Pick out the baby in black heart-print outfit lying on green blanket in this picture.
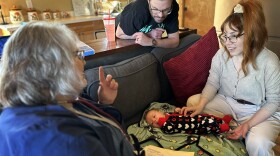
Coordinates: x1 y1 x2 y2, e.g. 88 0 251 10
144 108 232 134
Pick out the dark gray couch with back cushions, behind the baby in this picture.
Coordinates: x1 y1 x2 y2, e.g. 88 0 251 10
85 34 201 126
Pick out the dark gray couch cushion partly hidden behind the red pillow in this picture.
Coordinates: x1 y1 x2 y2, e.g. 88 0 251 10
151 34 201 104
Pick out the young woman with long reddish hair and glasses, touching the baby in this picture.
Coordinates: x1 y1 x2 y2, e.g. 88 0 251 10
183 0 280 156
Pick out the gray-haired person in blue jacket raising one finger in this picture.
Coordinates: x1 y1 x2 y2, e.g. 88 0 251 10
0 22 133 156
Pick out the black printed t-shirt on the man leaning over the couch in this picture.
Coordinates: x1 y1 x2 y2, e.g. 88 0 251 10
120 0 179 36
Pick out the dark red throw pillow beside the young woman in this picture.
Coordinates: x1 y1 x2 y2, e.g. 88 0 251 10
163 27 219 106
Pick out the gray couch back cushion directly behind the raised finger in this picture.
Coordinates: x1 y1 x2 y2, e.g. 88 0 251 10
85 53 160 125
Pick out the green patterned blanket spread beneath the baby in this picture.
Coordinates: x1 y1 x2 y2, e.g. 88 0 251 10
128 102 248 156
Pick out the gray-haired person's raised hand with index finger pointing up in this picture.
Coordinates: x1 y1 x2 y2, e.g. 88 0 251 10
97 67 119 104
